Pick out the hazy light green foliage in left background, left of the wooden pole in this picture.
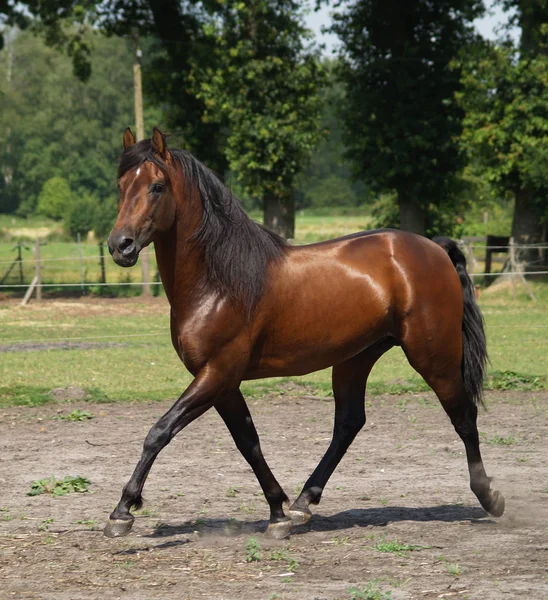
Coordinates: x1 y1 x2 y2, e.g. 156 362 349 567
0 32 139 218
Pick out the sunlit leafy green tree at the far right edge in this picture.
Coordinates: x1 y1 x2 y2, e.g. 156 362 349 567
457 0 548 253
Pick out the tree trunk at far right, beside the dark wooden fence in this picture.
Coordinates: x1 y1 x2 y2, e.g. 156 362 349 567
512 189 543 263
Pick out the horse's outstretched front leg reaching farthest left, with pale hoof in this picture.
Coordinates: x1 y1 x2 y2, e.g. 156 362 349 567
104 368 226 537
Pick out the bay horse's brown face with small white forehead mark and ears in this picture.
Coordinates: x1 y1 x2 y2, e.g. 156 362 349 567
108 128 175 267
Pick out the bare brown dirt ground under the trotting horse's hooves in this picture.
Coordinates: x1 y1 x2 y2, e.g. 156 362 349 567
0 392 548 600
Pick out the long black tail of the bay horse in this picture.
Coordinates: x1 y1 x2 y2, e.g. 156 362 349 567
432 237 487 404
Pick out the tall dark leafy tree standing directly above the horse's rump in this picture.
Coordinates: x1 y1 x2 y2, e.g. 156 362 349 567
333 0 483 234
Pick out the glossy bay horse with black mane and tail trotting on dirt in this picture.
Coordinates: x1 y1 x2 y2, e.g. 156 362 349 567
105 129 504 537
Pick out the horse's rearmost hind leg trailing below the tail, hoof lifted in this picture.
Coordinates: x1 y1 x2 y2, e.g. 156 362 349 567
404 343 504 517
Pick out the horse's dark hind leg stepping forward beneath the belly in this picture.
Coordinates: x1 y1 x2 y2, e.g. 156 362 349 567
289 338 394 525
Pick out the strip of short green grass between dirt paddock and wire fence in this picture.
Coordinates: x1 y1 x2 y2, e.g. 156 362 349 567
0 284 548 405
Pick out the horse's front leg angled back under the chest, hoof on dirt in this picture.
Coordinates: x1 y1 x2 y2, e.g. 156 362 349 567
215 390 293 539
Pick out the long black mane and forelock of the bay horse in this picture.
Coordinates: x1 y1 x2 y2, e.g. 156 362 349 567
118 140 287 314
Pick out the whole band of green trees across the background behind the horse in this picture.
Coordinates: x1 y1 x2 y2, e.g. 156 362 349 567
0 0 548 242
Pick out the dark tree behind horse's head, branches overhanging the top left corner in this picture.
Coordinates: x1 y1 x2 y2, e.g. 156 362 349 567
0 0 227 173
